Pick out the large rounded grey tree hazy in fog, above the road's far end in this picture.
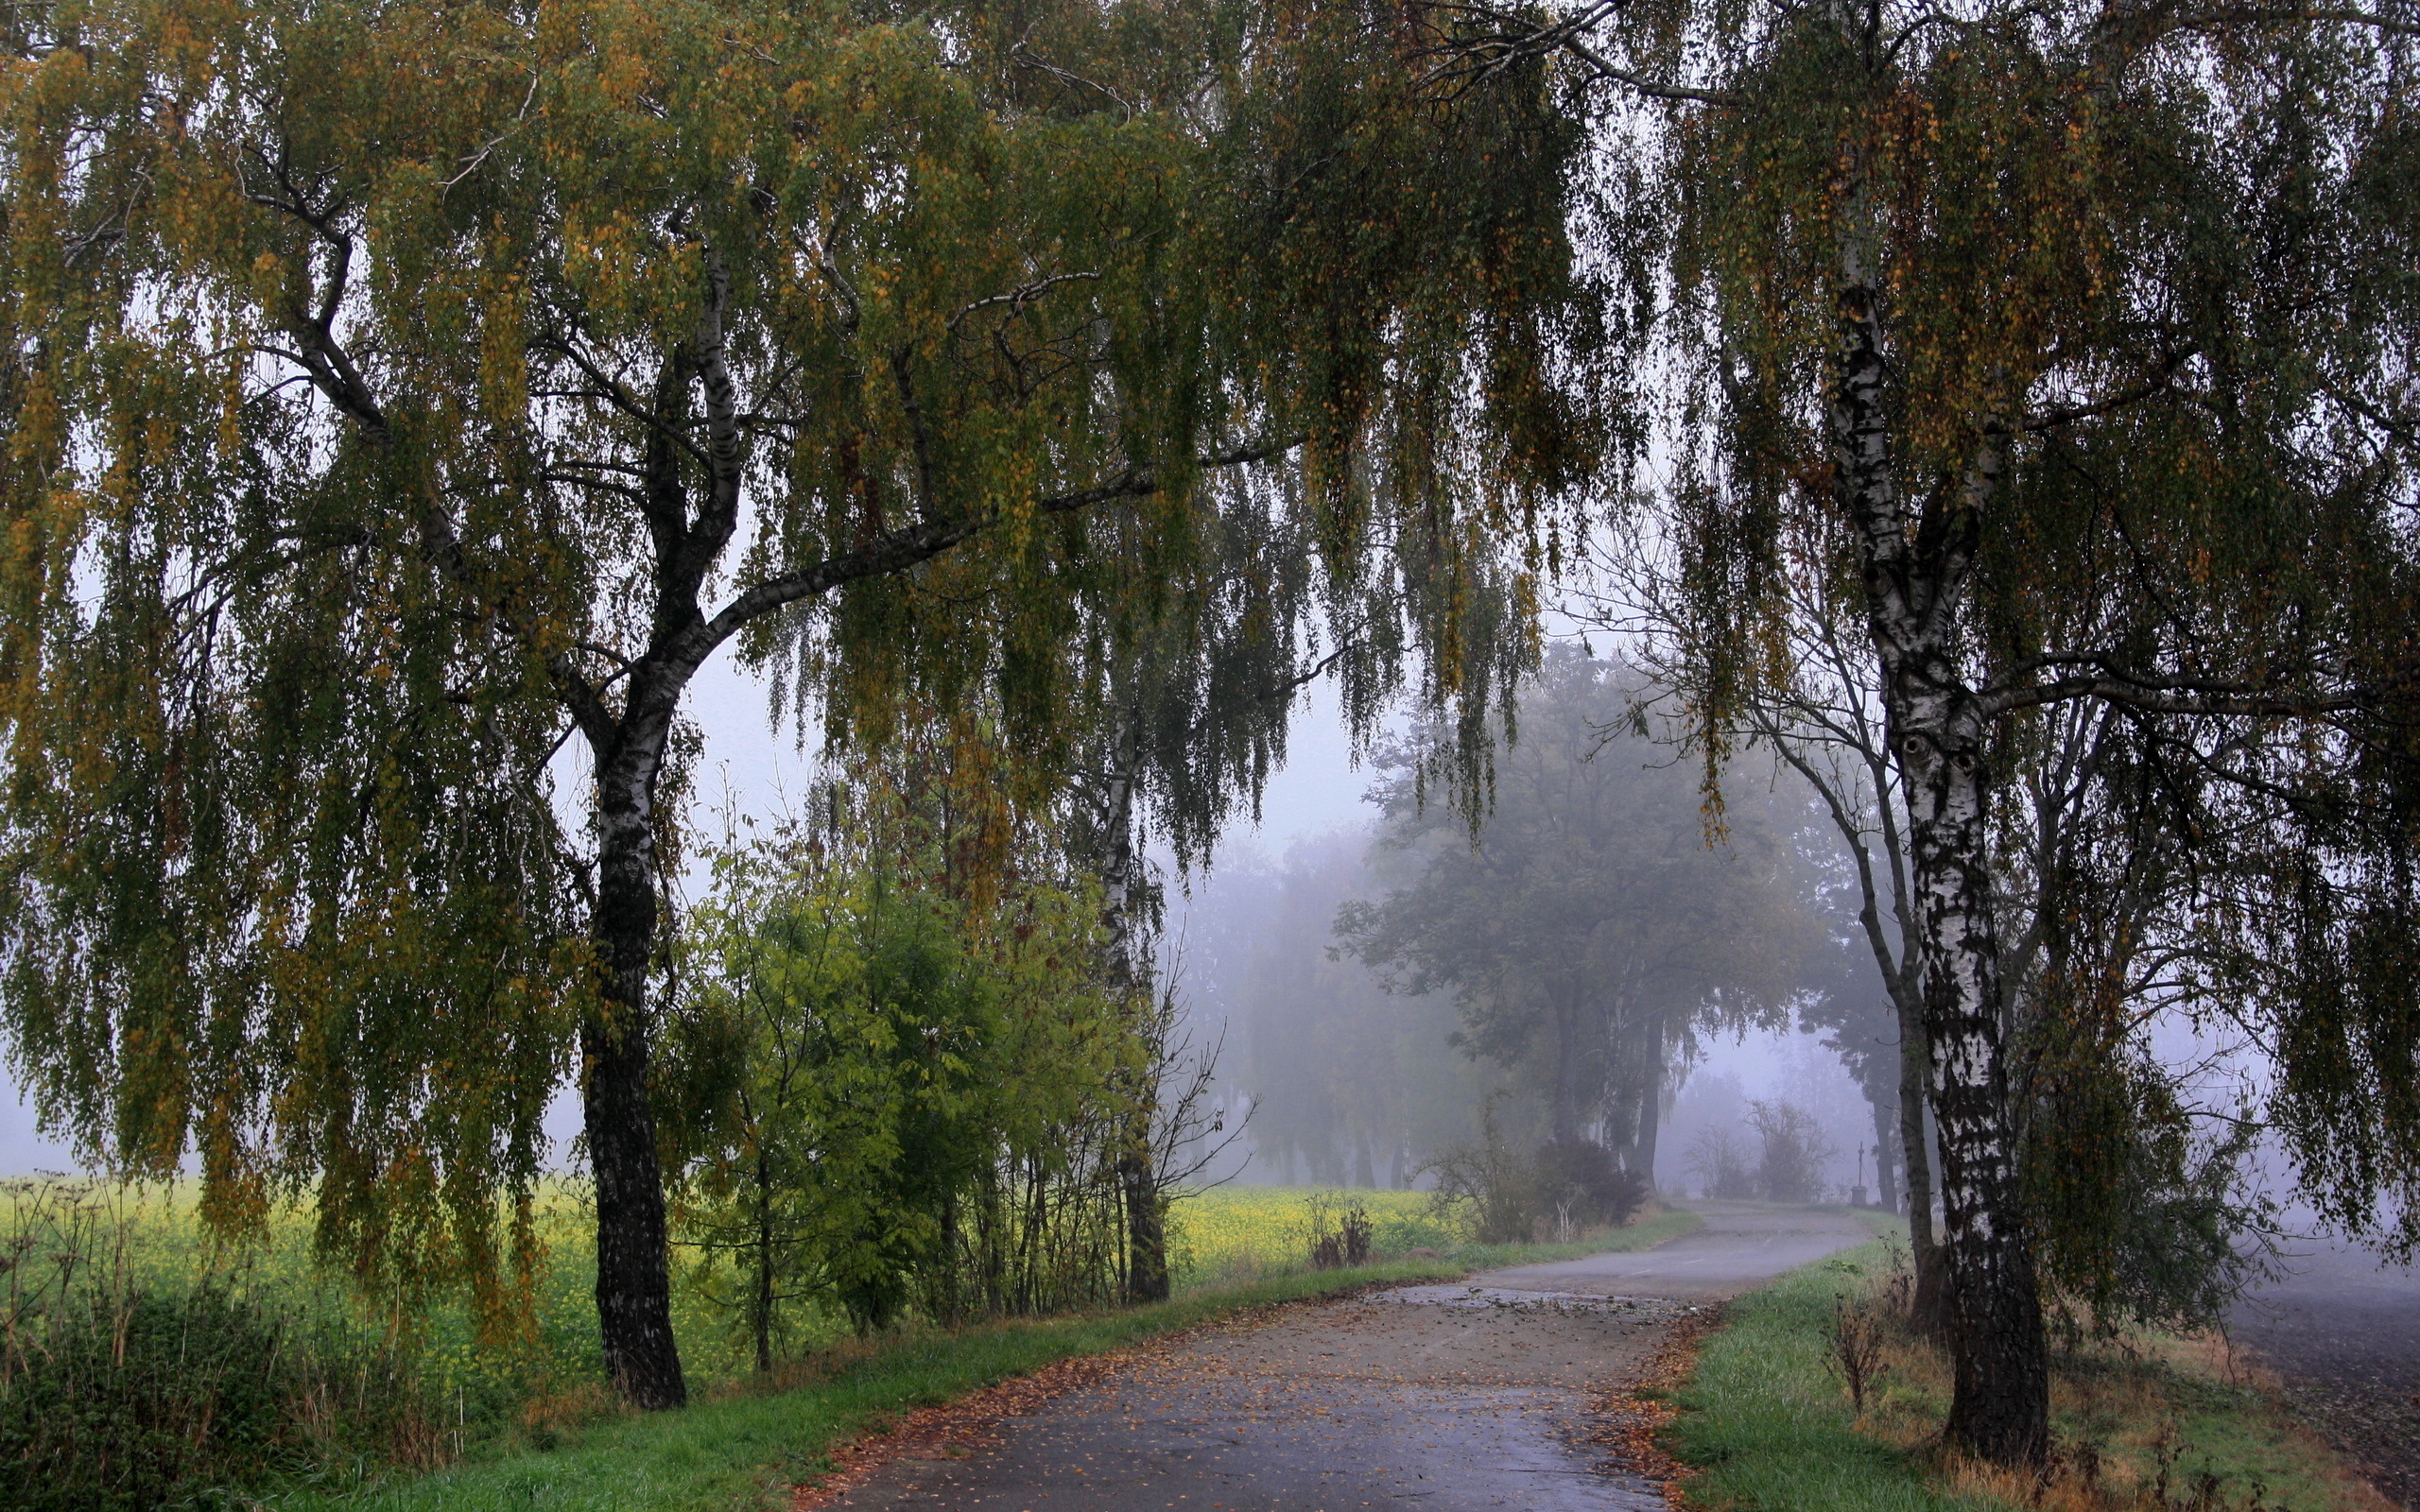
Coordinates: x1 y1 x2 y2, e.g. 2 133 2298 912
1336 648 1803 1178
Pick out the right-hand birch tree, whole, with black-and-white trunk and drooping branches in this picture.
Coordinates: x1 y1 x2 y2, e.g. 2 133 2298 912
1435 0 2420 1464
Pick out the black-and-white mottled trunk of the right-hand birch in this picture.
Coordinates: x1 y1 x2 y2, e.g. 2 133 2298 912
1829 167 2049 1466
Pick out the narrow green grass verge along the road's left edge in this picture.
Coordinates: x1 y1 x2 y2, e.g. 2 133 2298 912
256 1212 1702 1512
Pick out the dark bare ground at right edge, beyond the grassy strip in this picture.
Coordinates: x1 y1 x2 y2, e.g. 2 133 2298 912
2229 1241 2420 1512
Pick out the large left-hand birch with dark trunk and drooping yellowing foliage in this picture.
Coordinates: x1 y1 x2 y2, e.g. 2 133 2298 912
0 0 1604 1408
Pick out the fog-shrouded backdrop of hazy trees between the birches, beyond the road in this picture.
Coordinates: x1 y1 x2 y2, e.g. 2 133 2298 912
1171 648 1900 1205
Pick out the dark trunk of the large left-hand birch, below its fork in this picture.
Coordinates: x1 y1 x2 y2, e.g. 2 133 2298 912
580 747 690 1408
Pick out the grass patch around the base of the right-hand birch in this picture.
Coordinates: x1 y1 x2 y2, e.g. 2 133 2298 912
1665 1214 2386 1512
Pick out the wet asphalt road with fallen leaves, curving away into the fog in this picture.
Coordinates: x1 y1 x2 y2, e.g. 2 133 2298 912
828 1202 1871 1512
